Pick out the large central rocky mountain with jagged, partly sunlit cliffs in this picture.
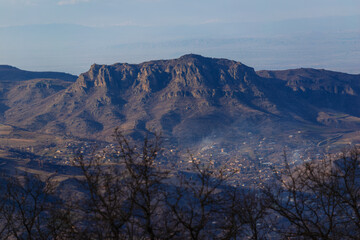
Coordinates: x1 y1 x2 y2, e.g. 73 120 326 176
60 55 277 141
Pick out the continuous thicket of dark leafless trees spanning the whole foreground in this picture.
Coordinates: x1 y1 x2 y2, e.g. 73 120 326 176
8 130 354 240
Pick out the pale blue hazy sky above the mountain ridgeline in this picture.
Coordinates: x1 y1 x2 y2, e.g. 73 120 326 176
0 0 360 74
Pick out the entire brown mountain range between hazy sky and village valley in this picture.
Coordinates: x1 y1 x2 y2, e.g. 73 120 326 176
0 54 360 151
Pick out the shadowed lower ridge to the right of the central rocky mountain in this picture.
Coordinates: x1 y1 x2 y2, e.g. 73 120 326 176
257 68 360 127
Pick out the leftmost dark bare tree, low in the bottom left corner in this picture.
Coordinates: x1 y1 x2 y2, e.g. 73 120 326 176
1 173 56 239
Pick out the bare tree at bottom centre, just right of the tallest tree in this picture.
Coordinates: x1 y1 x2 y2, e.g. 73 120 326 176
167 157 234 239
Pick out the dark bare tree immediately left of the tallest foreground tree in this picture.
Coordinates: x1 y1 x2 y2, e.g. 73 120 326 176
73 144 134 239
